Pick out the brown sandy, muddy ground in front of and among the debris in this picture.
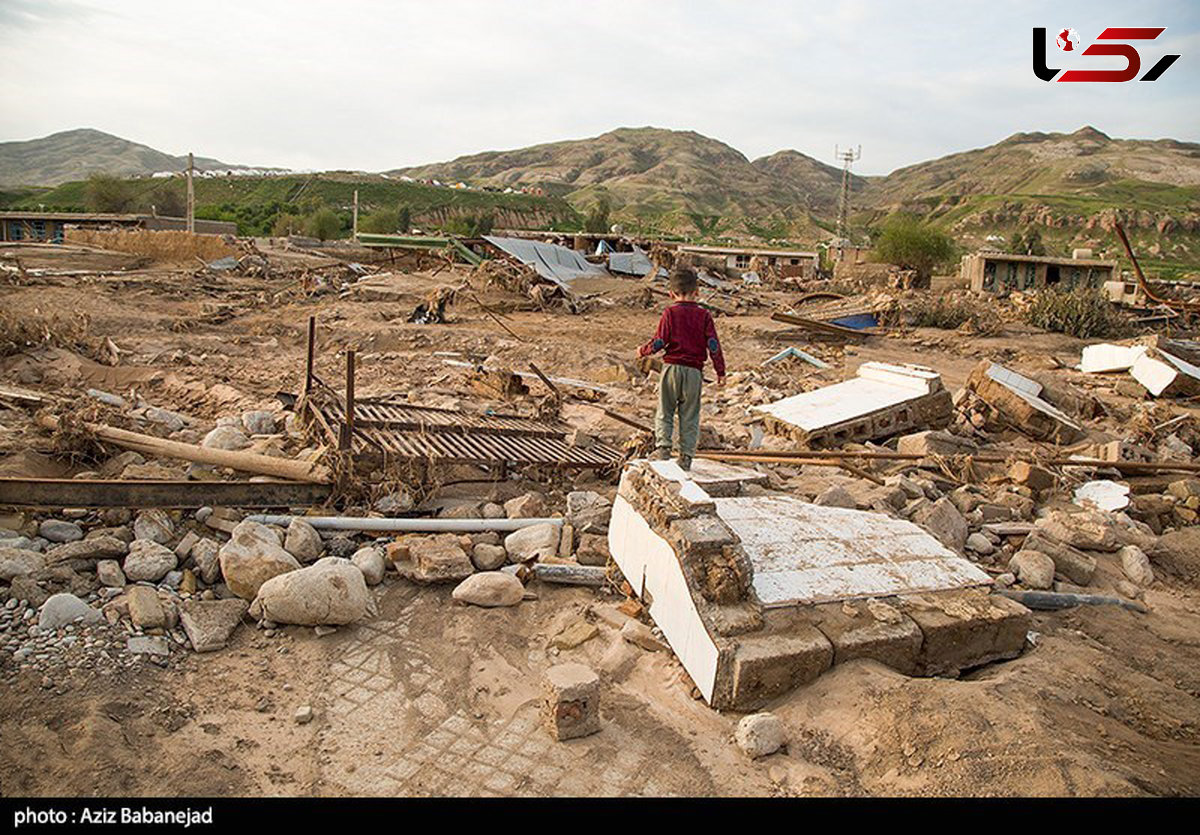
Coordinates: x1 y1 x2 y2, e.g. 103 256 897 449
0 243 1200 795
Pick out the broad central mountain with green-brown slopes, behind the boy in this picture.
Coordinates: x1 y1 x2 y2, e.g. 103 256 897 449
388 127 841 236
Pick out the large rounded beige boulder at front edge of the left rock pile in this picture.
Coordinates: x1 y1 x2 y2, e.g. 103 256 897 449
251 557 371 626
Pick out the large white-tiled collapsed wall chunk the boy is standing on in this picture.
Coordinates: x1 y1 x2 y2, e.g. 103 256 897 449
608 459 1028 710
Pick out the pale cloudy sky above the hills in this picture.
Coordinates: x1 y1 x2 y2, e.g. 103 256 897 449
0 0 1200 174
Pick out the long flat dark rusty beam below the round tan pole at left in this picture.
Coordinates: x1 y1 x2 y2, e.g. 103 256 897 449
0 479 332 507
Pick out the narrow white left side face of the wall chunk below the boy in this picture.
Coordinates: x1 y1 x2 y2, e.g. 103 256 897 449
608 495 718 702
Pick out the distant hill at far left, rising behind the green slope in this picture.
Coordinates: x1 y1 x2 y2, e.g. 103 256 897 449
0 127 245 186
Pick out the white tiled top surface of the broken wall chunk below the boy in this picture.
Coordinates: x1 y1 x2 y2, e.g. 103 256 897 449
714 495 991 608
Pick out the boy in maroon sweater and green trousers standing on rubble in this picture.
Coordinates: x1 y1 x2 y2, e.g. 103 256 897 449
637 266 725 470
